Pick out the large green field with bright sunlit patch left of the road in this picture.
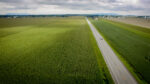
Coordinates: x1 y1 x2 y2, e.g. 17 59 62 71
0 17 113 84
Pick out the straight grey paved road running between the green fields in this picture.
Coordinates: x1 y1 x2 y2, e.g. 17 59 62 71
86 19 137 84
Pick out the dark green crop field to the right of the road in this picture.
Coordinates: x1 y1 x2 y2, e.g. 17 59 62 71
91 18 150 83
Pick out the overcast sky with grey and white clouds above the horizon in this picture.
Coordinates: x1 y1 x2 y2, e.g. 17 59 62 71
0 0 150 15
